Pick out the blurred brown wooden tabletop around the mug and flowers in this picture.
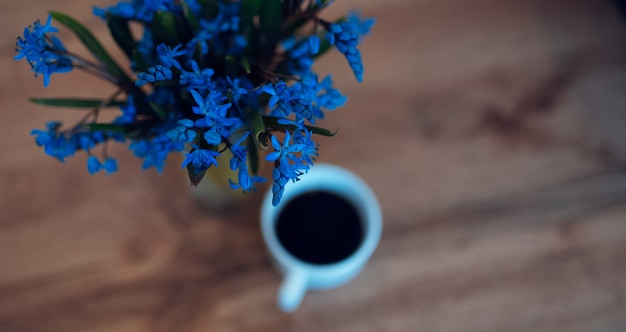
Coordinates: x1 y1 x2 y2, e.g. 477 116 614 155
0 0 626 332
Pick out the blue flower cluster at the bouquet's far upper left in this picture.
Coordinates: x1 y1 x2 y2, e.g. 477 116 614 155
14 16 74 87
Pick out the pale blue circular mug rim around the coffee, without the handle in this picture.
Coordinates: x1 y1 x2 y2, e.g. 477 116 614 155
261 164 382 273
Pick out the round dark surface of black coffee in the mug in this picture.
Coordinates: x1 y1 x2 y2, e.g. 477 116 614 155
276 191 363 264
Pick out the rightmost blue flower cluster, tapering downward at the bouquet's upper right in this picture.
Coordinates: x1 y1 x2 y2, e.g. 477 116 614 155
326 13 375 82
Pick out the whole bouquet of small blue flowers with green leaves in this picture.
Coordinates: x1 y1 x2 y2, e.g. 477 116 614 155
15 0 374 205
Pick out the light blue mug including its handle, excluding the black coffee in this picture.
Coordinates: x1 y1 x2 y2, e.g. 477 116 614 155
261 164 382 312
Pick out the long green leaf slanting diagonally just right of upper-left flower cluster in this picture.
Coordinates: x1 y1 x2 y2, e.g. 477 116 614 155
50 11 132 83
